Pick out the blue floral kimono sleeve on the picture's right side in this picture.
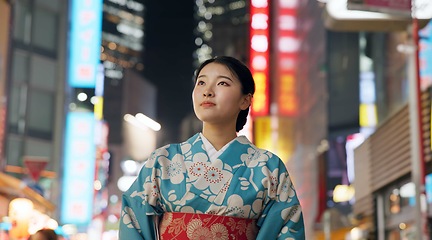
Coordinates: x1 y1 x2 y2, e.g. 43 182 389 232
257 159 305 240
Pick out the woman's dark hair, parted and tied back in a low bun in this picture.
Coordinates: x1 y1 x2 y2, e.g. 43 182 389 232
195 56 255 132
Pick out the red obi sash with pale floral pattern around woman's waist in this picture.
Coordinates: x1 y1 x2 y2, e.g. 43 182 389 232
159 212 258 240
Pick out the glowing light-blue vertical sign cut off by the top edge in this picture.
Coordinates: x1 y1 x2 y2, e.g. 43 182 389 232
69 0 102 88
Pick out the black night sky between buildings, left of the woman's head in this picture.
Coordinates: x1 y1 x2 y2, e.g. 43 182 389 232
143 0 195 146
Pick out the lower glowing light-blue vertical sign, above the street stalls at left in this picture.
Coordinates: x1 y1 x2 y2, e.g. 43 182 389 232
60 112 96 225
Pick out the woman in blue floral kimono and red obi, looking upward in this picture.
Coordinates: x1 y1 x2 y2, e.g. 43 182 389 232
120 56 305 240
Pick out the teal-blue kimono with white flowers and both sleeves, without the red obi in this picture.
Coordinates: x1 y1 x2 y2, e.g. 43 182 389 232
119 134 305 240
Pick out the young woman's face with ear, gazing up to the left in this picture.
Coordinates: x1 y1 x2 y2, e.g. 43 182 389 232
192 63 250 126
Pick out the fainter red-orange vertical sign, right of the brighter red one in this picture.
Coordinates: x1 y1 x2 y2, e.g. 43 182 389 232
274 0 299 116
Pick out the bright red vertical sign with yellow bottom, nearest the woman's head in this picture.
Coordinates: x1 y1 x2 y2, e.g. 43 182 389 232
250 0 270 116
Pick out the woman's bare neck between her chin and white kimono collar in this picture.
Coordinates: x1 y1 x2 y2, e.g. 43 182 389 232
202 124 237 150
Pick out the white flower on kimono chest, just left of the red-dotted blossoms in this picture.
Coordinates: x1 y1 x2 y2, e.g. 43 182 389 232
159 154 185 184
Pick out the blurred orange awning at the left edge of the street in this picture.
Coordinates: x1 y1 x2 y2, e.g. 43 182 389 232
0 172 56 211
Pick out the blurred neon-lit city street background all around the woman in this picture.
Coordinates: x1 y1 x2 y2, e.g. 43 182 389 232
0 0 432 240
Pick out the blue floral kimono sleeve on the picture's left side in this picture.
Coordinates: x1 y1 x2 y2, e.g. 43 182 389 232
119 155 162 240
